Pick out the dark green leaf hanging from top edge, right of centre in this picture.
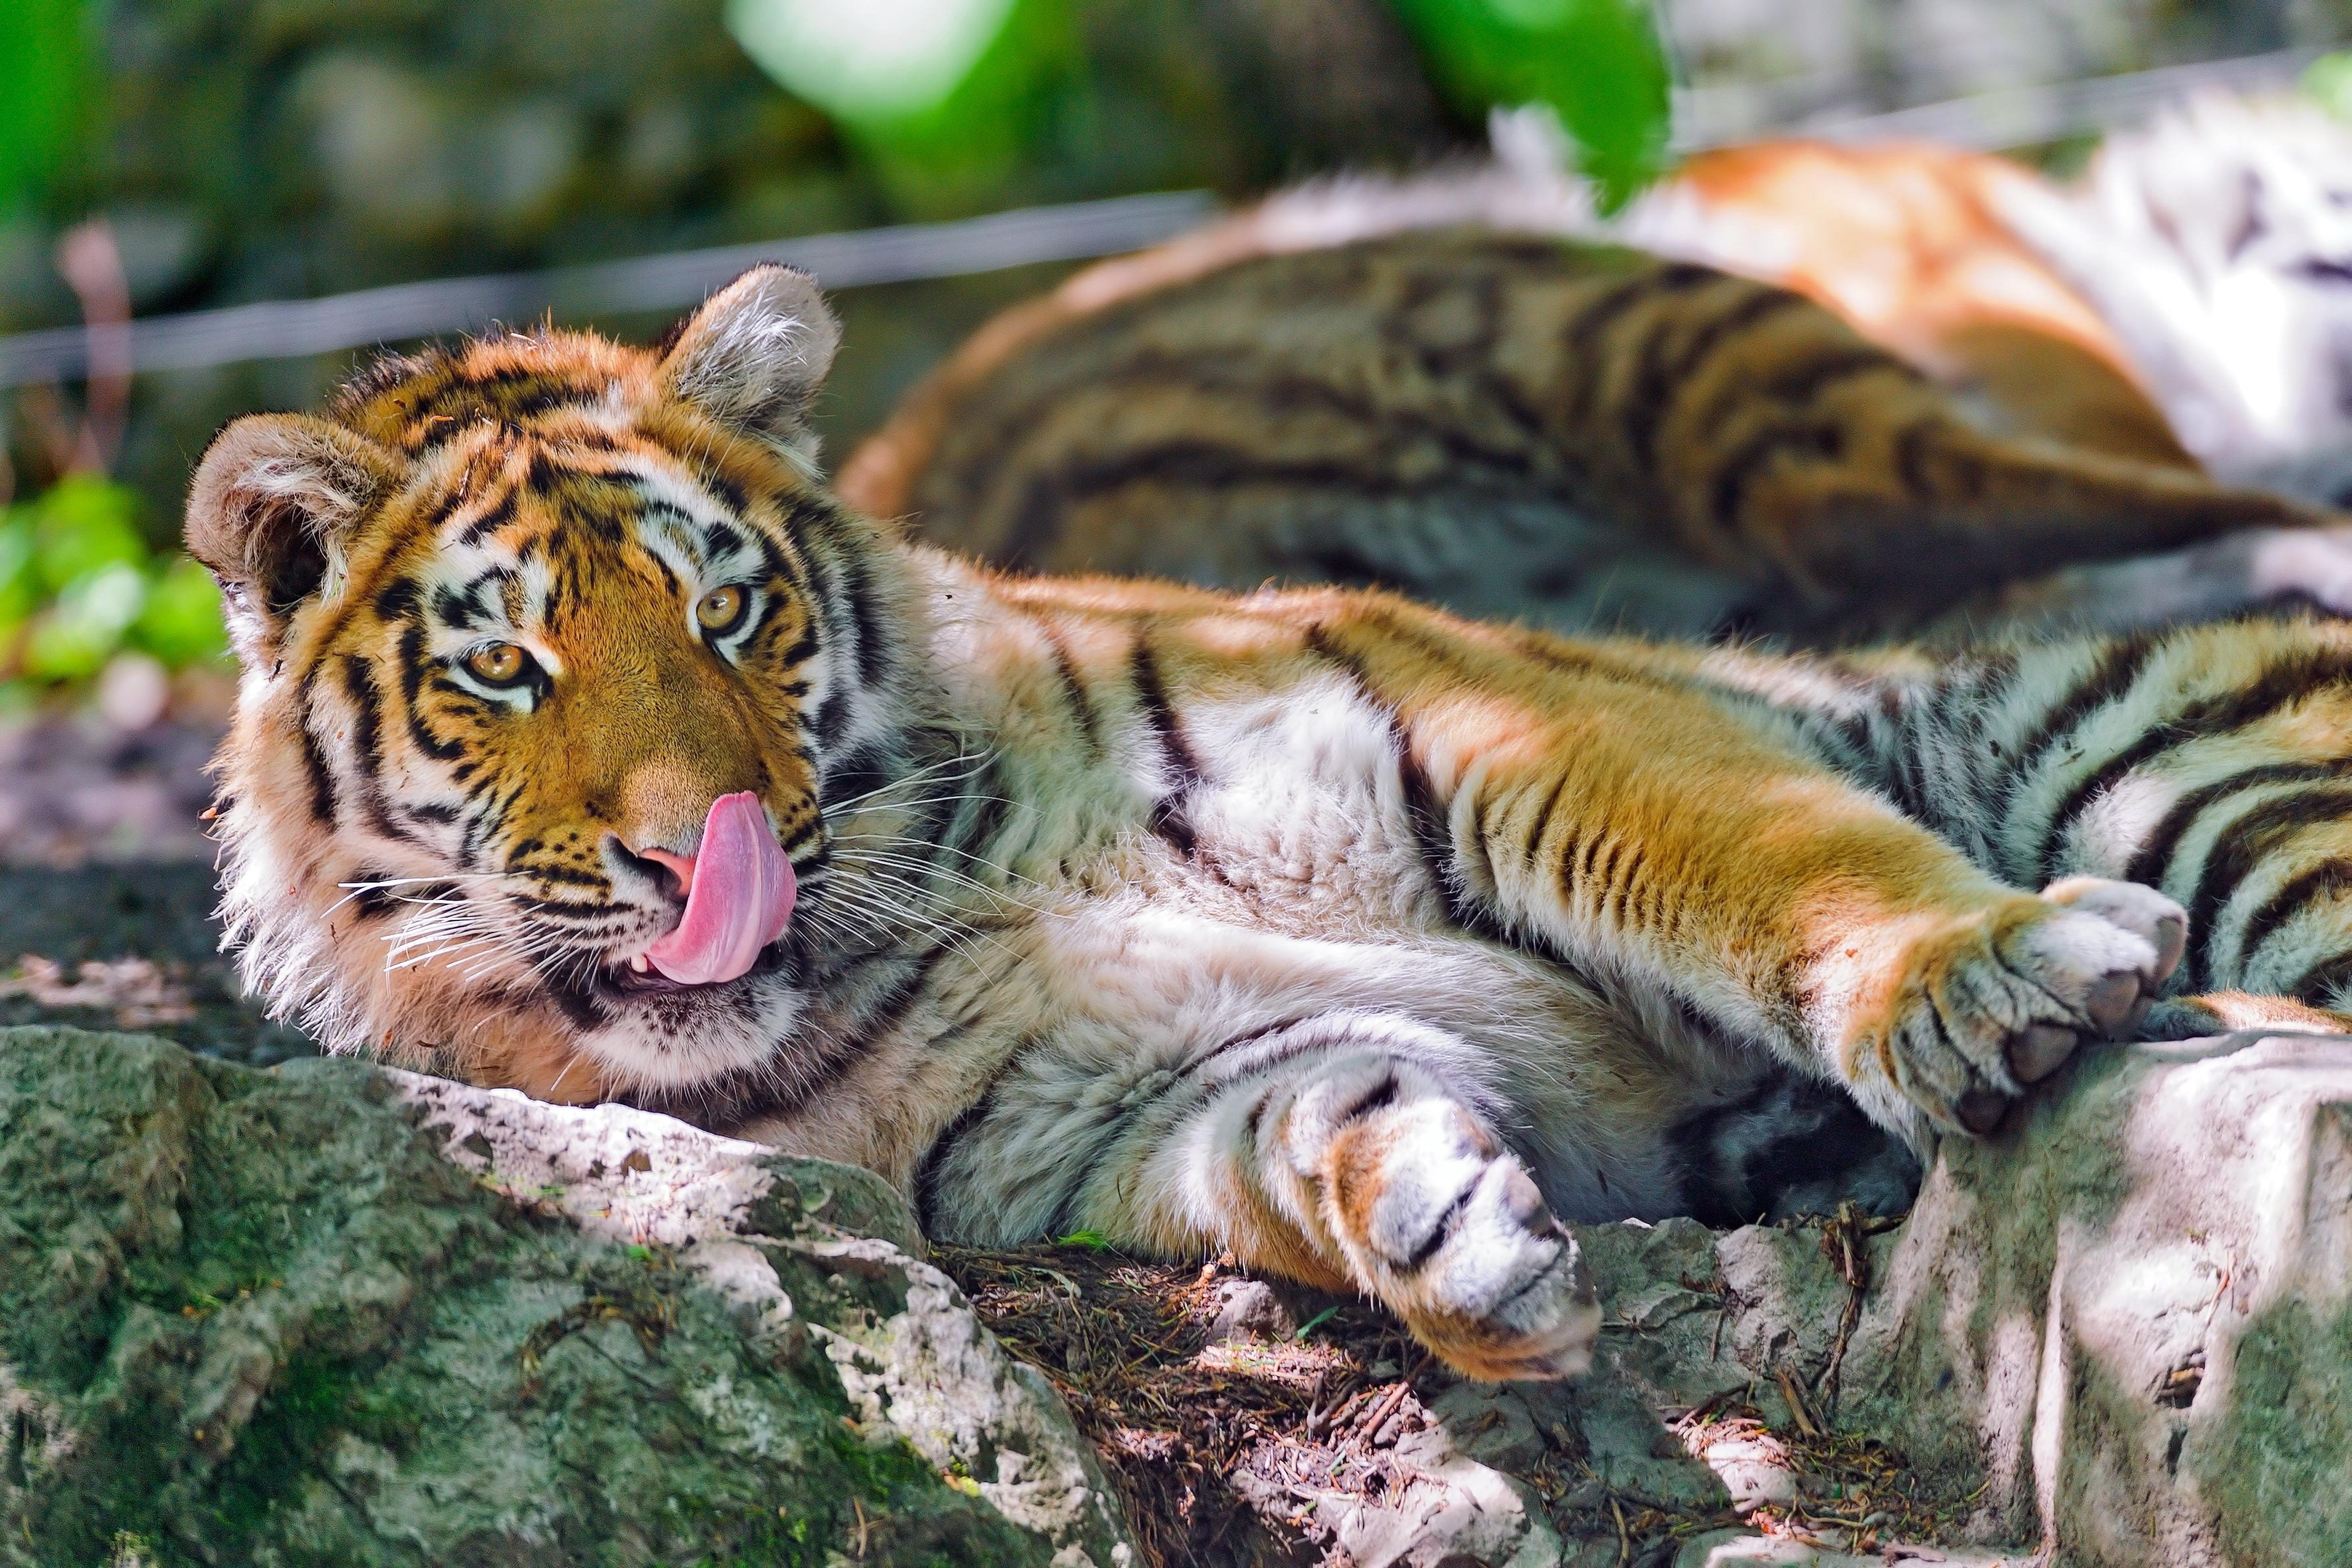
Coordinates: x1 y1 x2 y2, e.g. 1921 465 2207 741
1392 0 1673 212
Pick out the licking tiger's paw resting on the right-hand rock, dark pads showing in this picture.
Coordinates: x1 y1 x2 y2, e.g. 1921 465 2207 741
1858 877 2187 1138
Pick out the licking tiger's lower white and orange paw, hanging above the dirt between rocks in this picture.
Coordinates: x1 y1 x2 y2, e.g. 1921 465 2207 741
1301 1063 1601 1382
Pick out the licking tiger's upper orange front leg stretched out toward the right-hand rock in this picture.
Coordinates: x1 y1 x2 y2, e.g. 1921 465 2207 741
1373 652 2187 1138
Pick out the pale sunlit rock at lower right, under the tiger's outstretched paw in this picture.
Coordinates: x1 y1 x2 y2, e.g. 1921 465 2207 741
1842 1037 2352 1568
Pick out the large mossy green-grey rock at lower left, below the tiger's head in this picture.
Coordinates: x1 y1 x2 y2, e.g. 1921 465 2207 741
0 1027 1134 1568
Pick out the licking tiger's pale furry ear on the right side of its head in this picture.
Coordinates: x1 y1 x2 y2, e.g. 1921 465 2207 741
661 263 842 456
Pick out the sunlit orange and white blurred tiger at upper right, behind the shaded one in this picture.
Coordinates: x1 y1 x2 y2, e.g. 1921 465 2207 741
1618 92 2352 503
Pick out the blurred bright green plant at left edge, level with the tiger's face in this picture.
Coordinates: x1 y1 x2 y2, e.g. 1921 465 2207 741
0 475 228 687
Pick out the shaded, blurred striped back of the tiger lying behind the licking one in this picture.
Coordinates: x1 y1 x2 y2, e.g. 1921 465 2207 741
842 221 2314 640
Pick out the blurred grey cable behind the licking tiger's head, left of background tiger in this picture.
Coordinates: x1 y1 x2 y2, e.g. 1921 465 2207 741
0 191 1216 386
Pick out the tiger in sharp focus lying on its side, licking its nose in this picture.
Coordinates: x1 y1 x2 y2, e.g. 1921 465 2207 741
186 266 2352 1380
